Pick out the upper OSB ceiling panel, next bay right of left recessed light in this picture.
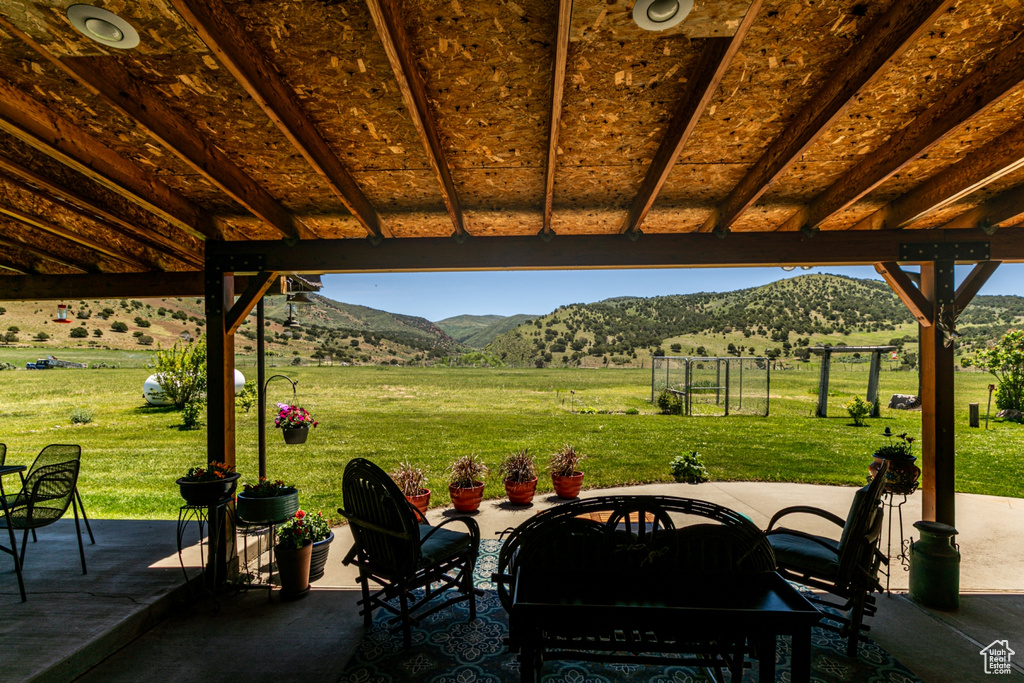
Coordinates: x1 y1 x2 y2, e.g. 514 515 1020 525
231 0 436 174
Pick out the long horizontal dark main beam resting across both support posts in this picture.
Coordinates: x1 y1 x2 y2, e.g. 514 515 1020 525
207 228 1024 273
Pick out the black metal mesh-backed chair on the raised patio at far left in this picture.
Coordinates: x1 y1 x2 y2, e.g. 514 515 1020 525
0 460 87 589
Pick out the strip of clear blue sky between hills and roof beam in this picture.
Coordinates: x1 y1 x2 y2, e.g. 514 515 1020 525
322 264 1024 322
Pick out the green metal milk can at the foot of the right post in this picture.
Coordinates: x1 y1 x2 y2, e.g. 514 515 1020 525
910 521 959 609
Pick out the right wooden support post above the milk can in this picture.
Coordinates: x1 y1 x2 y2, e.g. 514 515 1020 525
921 260 956 525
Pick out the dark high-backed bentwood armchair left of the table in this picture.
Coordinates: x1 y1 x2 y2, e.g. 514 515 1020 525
338 458 482 648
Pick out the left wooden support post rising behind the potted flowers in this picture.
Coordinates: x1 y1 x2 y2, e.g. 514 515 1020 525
206 266 238 581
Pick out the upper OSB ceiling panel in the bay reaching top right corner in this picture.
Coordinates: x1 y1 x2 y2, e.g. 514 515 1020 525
804 2 1024 163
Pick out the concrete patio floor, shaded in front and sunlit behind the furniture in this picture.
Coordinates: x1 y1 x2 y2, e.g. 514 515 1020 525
0 482 1024 682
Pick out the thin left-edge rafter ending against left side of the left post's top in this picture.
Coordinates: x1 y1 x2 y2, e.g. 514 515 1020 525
0 155 203 268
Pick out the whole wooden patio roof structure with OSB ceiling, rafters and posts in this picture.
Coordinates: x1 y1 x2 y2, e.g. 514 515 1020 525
0 0 1024 544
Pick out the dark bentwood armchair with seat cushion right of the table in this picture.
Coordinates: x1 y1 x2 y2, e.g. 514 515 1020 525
765 462 889 657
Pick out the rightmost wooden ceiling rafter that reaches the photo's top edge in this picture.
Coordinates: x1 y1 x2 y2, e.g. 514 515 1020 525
699 0 953 232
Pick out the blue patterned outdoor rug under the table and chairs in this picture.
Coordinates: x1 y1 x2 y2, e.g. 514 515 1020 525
341 540 922 683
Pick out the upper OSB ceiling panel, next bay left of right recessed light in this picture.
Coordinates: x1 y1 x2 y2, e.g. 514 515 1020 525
402 0 557 169
